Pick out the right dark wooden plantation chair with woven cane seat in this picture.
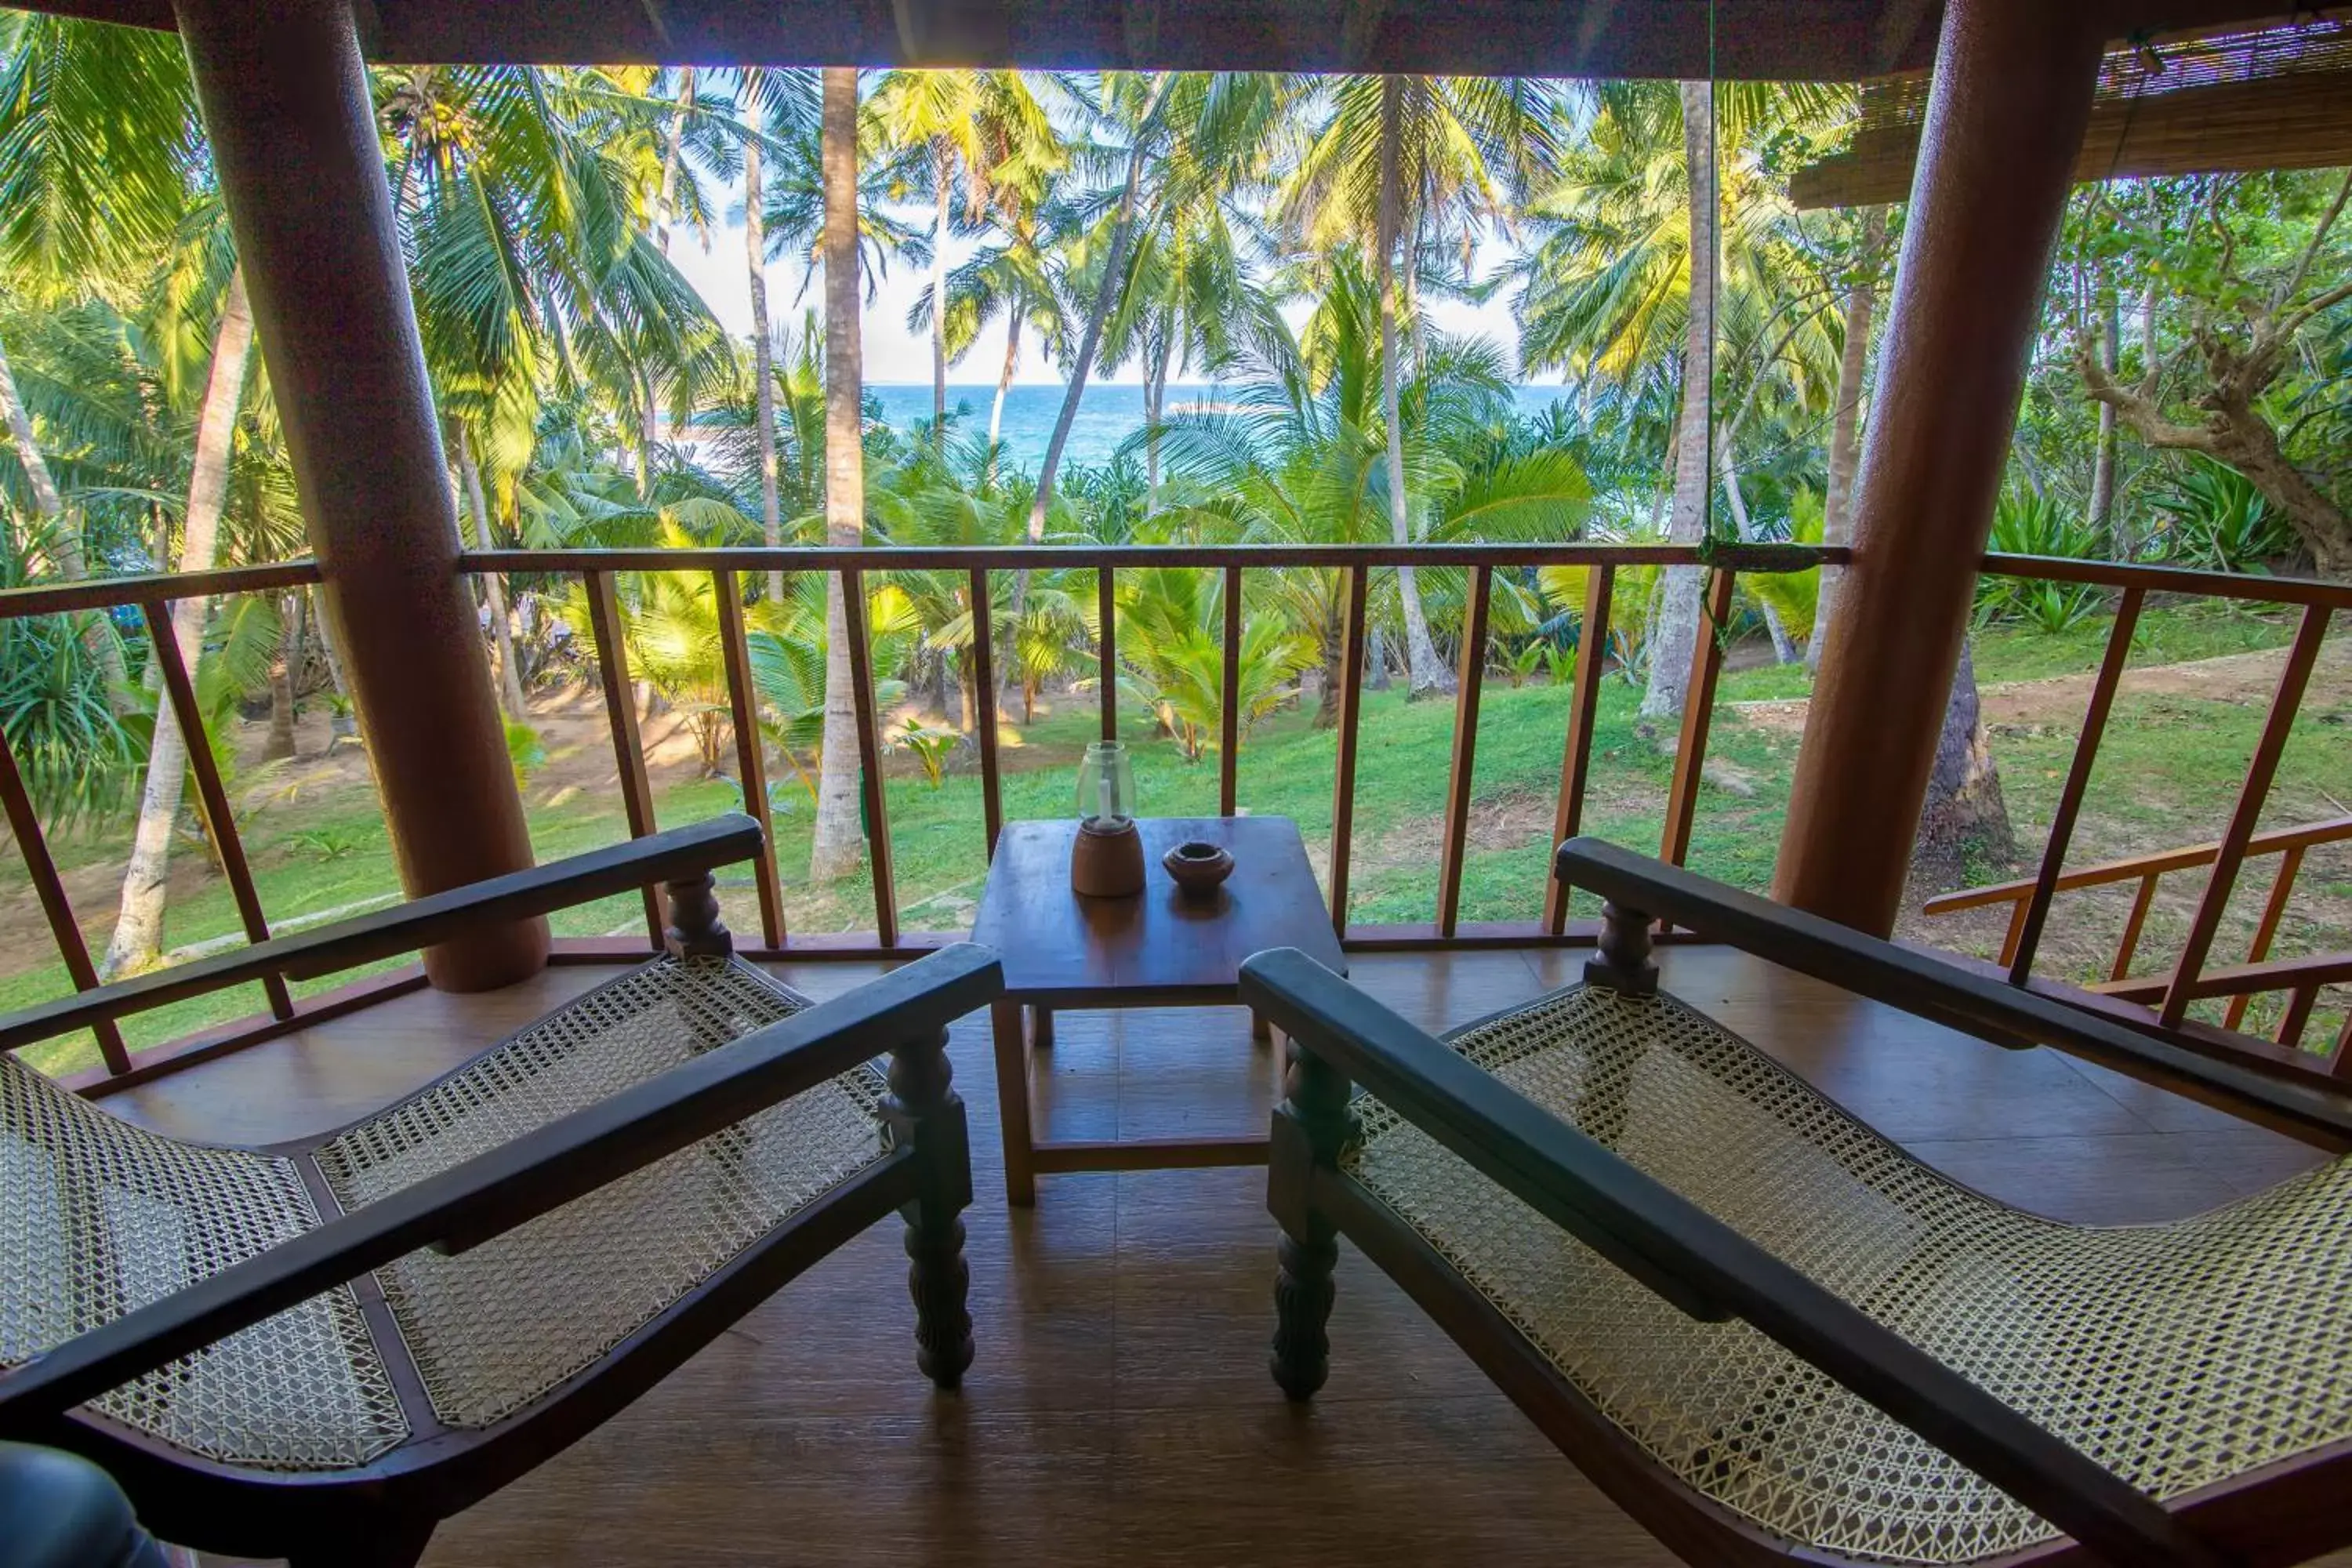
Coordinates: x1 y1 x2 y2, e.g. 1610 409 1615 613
1242 839 2352 1566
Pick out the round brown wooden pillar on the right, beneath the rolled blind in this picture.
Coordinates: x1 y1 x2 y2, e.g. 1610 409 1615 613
1773 0 2103 935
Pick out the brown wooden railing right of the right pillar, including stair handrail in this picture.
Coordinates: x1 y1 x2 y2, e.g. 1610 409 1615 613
1924 555 2352 1048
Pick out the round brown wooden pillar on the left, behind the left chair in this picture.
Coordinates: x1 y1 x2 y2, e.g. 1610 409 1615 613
174 0 548 989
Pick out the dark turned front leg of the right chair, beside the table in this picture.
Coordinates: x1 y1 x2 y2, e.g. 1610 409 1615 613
1265 1039 1352 1399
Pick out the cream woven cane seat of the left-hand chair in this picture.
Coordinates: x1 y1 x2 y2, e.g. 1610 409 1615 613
0 956 887 1472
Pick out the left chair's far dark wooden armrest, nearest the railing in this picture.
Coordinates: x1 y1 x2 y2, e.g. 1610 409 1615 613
0 813 762 1051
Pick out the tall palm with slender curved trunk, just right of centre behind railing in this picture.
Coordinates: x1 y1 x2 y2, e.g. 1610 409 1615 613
1277 75 1548 696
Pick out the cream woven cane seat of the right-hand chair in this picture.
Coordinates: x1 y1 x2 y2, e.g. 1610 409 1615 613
1341 987 2352 1563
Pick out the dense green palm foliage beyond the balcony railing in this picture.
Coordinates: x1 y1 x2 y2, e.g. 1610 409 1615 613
0 24 2352 966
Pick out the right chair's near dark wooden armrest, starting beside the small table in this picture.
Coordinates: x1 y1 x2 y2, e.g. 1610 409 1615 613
1242 947 2220 1563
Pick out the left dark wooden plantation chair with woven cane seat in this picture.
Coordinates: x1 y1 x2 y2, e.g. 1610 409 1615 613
0 815 1000 1568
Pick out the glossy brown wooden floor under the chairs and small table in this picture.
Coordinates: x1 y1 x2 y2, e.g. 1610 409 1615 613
108 947 2314 1568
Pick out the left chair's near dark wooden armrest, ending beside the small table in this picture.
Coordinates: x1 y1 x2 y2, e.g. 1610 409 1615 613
0 942 1004 1432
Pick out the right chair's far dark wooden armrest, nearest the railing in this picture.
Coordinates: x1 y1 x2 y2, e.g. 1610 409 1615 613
1555 839 2352 1149
